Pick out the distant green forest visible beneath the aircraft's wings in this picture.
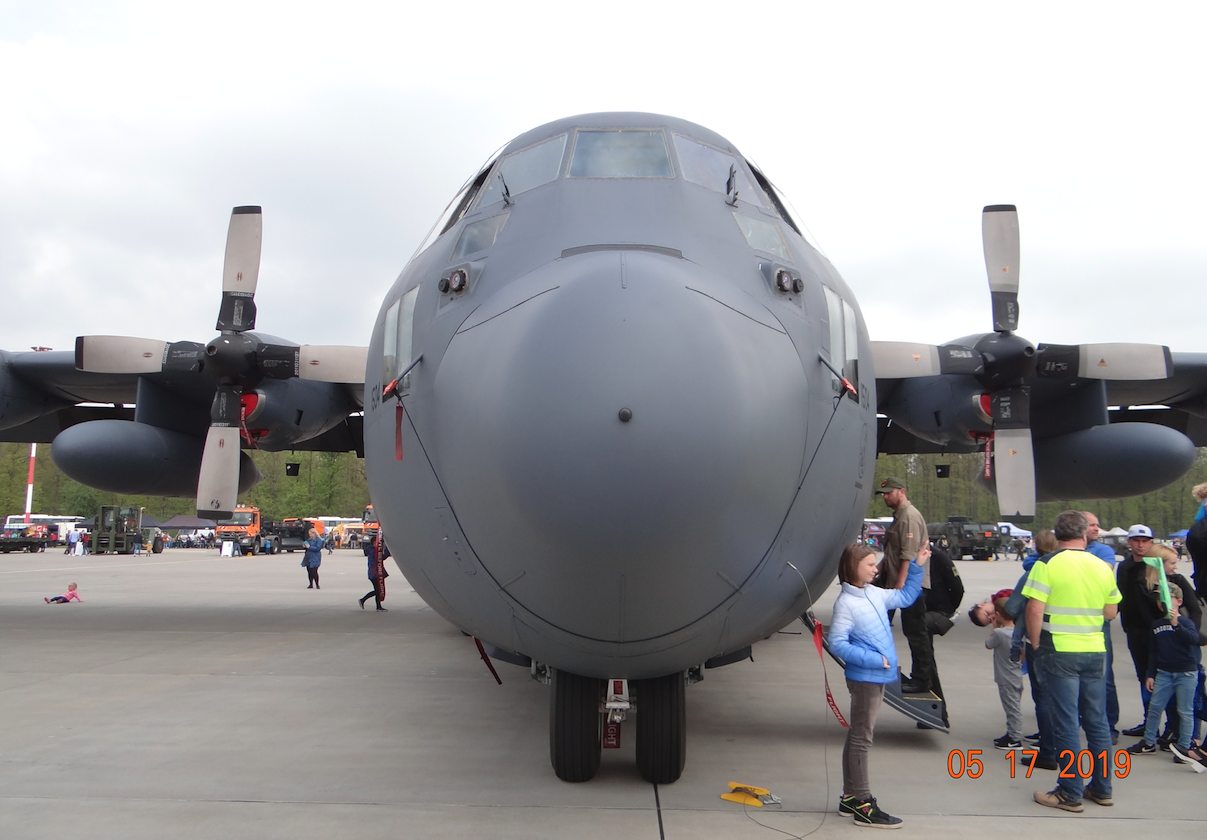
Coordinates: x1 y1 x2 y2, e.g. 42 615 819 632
0 443 1207 536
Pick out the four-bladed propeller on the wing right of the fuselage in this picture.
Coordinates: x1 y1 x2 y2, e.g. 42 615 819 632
871 204 1173 521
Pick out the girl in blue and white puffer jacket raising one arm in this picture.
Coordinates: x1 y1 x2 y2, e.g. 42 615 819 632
829 543 931 828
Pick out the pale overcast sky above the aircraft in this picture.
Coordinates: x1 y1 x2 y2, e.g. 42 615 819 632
0 0 1207 351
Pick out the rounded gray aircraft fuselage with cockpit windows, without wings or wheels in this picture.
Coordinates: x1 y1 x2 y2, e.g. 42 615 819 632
365 113 876 678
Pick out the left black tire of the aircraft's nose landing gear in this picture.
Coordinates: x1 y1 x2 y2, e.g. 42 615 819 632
549 669 604 782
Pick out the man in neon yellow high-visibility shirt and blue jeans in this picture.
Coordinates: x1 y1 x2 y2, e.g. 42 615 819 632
1022 511 1121 813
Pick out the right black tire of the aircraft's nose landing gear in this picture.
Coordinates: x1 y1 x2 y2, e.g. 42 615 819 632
634 672 687 784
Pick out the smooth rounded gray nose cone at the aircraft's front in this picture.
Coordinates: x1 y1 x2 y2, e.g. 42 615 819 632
433 251 806 641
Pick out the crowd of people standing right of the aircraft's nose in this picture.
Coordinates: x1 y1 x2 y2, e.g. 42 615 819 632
829 477 1207 828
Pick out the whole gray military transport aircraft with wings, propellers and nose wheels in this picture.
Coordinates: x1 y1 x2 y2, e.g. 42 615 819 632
0 113 1207 783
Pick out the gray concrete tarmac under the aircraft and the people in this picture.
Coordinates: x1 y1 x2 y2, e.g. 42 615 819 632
0 549 1207 840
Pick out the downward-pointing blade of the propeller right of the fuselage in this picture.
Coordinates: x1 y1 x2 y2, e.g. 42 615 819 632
991 386 1036 523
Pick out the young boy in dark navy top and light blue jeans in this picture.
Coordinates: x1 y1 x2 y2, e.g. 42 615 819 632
1127 583 1207 772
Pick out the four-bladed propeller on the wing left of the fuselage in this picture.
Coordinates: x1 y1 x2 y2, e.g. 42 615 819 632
76 206 368 519
